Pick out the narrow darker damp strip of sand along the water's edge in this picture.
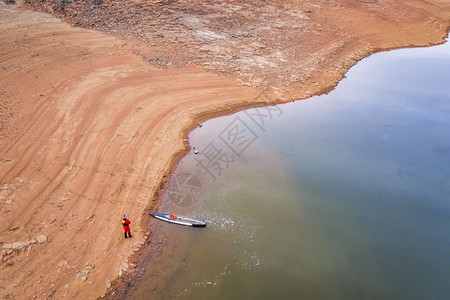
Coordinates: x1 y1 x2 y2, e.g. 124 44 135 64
1 1 450 296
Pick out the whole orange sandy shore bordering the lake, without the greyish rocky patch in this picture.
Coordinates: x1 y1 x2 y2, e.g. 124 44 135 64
0 1 450 299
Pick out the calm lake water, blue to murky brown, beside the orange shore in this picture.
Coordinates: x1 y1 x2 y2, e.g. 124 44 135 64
126 43 450 299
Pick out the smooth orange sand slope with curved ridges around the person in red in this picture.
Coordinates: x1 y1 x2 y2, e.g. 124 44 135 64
0 7 257 298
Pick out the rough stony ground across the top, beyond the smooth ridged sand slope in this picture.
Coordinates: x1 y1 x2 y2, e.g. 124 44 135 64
26 0 450 98
